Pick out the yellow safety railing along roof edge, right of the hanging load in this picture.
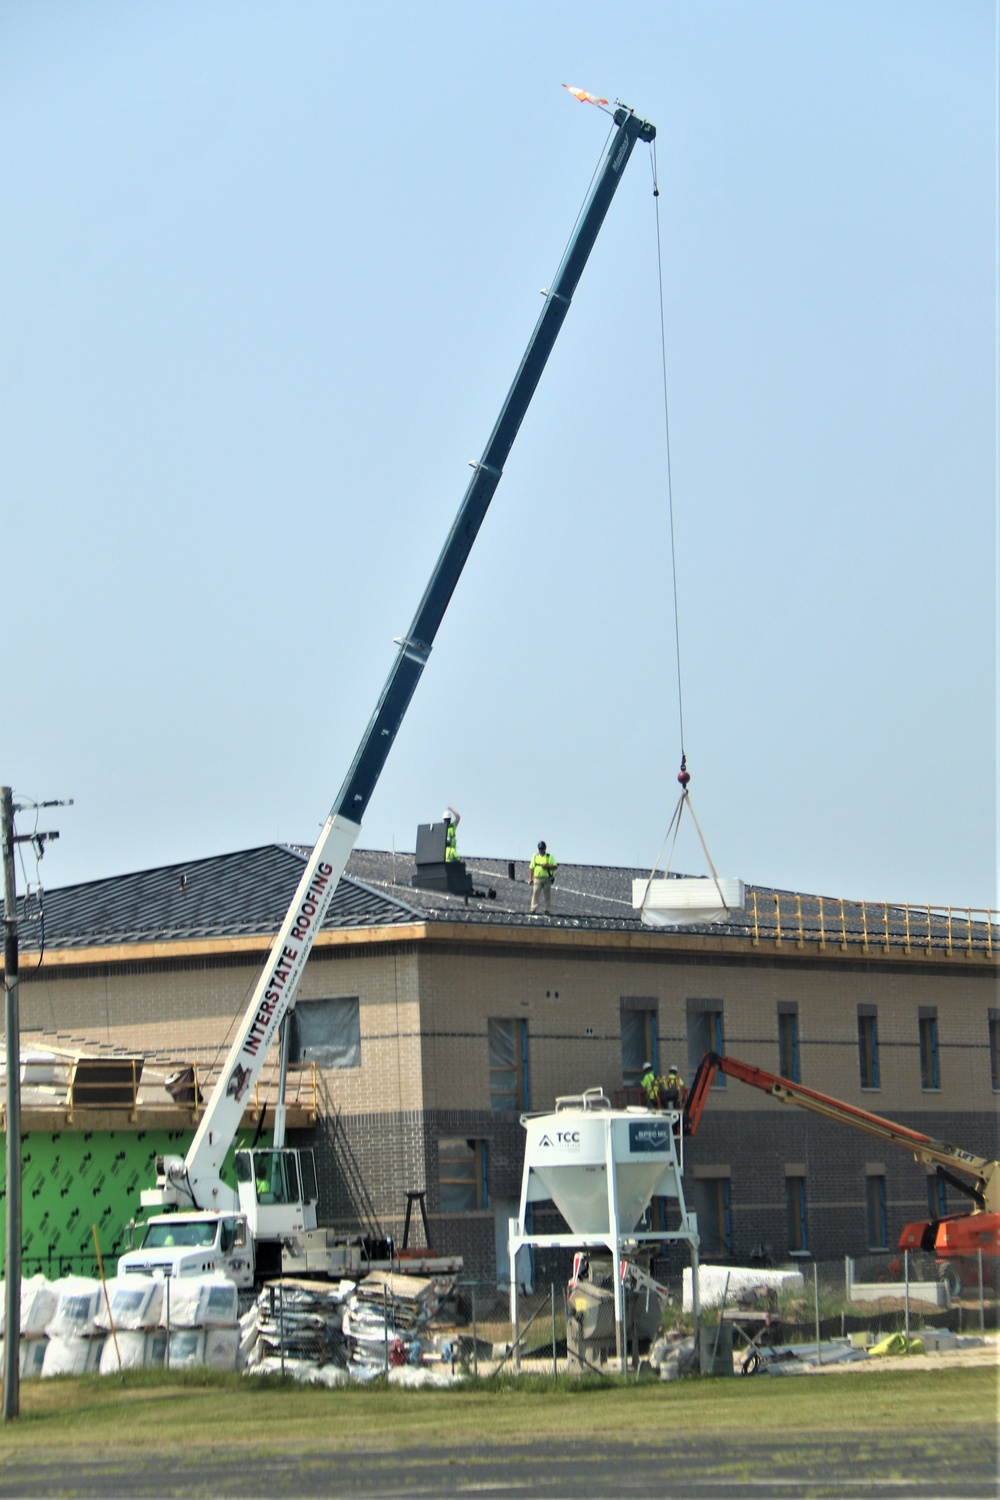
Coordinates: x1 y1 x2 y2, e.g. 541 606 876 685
747 890 1000 959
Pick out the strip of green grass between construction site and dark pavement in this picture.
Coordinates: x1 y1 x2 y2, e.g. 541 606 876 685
0 1367 997 1458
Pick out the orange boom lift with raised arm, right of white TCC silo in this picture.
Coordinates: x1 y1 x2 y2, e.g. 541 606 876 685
684 1052 1000 1292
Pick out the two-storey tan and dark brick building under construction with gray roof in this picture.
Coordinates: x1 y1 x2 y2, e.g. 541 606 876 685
0 845 1000 1284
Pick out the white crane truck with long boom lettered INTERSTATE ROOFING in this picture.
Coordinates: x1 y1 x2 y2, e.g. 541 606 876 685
118 104 657 1286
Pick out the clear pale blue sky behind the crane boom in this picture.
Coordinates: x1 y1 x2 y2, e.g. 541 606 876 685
0 0 1000 906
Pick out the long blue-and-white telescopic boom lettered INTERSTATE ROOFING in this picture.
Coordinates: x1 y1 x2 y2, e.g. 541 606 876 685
142 107 657 1209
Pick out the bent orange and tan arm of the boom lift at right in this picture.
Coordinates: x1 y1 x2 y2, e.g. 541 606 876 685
684 1052 1000 1214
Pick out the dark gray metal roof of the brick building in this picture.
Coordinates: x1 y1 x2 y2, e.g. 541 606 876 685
0 845 991 950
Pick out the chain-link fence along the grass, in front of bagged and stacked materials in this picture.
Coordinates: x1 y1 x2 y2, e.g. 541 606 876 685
3 1253 1000 1385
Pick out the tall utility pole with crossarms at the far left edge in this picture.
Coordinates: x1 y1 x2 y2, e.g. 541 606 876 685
0 786 70 1422
